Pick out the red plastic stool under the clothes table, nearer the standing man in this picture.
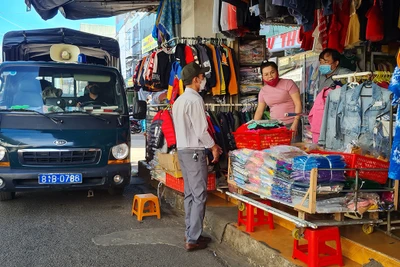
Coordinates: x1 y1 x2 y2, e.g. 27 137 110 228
238 199 275 232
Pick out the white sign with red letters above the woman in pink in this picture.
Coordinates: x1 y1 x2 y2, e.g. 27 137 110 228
267 30 301 52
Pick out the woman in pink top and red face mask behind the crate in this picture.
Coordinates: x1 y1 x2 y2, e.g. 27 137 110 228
254 61 302 141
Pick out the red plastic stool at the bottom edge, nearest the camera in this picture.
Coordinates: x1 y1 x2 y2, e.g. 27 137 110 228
292 227 343 267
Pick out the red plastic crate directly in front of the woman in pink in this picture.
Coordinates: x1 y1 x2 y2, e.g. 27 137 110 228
233 127 292 150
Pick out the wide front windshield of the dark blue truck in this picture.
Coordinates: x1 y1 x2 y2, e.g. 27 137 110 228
0 64 124 115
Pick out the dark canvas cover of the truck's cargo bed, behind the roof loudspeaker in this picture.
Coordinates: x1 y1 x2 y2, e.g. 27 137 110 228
3 28 119 63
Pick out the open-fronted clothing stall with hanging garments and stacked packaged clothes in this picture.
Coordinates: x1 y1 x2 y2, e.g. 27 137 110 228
133 0 400 266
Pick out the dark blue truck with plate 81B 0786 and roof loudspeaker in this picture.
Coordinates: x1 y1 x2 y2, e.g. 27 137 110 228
0 29 131 200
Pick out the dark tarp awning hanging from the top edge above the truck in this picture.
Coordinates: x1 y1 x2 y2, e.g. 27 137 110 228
25 0 160 20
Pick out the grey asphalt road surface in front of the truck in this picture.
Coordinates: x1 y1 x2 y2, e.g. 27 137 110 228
0 185 247 267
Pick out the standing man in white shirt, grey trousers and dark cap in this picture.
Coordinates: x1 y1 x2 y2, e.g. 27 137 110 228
172 62 222 251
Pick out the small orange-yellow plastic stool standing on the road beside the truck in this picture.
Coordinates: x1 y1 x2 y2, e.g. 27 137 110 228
132 194 161 221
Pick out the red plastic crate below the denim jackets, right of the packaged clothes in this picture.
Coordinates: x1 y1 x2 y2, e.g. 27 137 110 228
310 150 389 184
